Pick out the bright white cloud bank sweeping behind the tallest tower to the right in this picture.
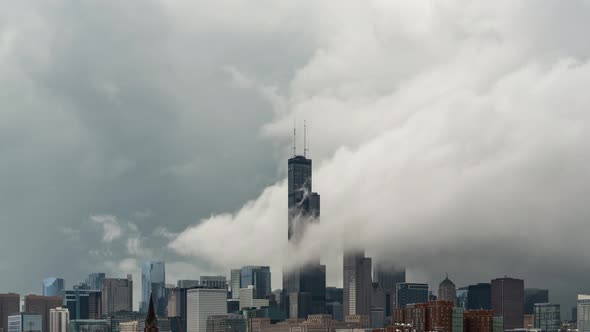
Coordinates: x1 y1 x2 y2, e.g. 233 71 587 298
170 1 590 314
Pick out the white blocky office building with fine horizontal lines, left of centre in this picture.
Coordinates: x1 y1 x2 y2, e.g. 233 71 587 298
186 288 227 332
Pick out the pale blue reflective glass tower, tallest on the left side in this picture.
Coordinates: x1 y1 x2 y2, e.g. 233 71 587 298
140 262 168 317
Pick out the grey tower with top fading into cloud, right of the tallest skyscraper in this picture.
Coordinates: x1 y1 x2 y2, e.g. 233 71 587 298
342 251 372 316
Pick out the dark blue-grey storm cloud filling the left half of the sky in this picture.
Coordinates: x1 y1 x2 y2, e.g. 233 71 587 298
0 1 314 300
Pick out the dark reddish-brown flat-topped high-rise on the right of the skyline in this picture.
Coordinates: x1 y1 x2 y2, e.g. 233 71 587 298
492 277 524 330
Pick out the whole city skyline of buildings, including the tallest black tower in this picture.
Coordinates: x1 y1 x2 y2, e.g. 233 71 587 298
0 143 590 332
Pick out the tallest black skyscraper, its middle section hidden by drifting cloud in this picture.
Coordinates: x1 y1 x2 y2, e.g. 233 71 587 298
284 134 326 316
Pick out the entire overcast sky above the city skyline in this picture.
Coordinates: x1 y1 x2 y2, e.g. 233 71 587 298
0 0 590 318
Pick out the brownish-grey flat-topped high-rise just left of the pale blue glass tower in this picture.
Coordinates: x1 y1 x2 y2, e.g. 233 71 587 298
102 274 133 315
